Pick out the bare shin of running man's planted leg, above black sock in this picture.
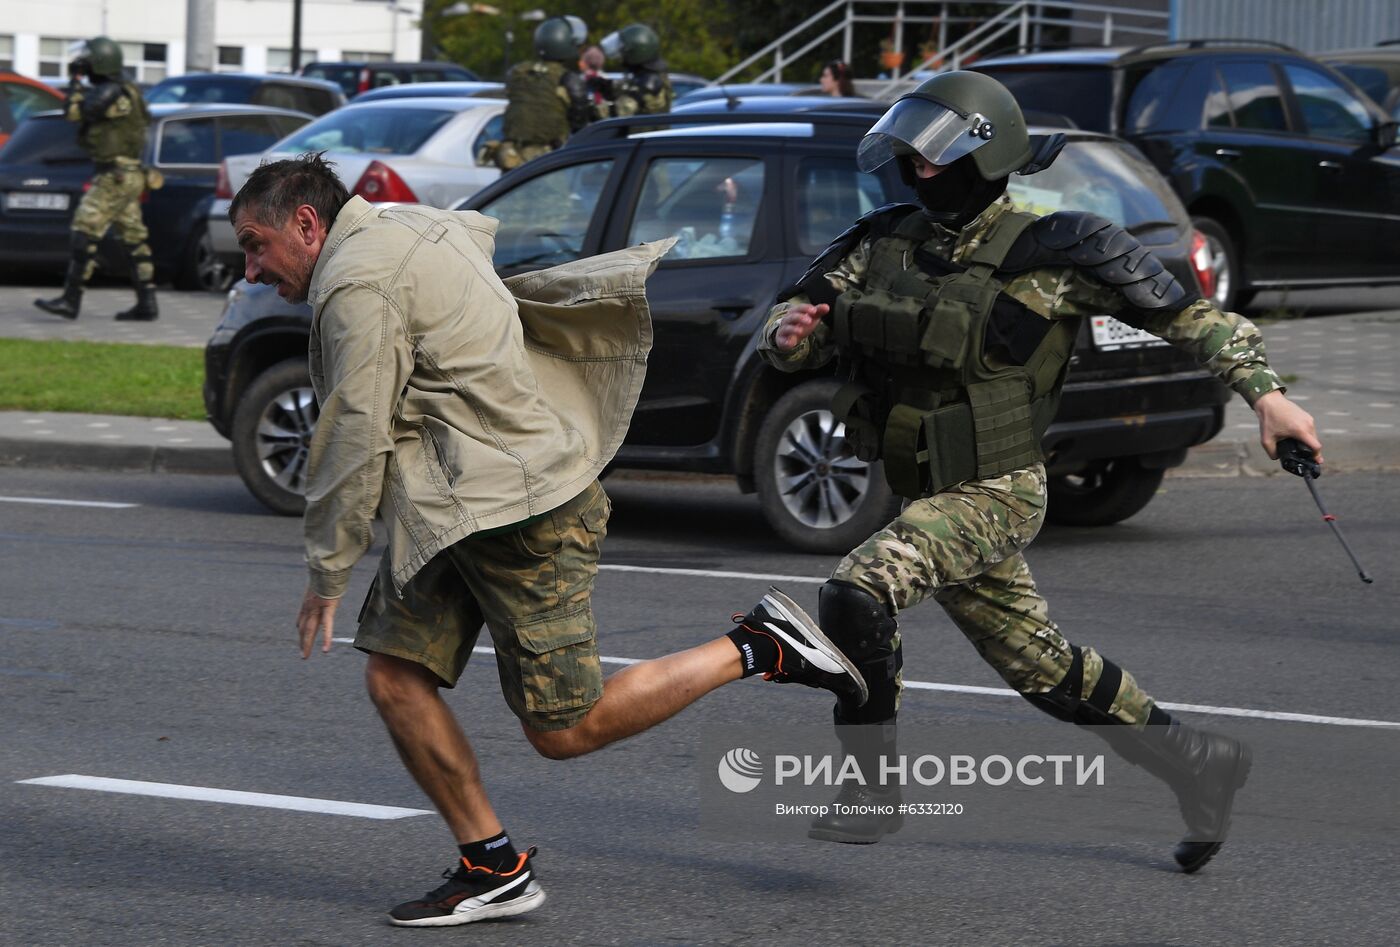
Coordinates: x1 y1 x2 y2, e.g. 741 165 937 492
365 647 504 845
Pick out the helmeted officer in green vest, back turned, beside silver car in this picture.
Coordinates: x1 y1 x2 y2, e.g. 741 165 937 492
494 17 592 171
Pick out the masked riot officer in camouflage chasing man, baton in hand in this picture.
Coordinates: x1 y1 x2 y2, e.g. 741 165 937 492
760 71 1320 871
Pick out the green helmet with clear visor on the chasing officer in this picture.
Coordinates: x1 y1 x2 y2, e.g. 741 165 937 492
855 71 1032 181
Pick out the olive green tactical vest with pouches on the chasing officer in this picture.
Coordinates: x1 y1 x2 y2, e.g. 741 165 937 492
829 213 1079 499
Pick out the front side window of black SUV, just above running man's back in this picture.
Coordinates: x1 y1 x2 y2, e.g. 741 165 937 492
480 158 612 269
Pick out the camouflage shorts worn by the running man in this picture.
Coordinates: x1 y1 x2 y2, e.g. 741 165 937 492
354 482 610 730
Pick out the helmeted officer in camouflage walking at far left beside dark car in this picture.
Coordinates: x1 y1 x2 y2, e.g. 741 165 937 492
34 36 160 321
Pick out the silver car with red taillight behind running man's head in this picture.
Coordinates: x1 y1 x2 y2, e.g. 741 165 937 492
209 98 505 264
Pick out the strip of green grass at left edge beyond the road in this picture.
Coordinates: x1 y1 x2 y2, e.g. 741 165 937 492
0 339 204 420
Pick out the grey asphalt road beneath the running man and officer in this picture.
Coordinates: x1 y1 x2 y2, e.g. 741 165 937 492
0 469 1400 947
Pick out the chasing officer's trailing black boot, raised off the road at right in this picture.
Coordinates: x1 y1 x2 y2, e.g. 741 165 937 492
1095 707 1253 874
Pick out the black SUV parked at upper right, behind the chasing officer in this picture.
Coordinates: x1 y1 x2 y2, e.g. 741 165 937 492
970 39 1400 308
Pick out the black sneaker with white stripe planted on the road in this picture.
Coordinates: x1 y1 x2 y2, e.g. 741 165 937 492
389 849 545 927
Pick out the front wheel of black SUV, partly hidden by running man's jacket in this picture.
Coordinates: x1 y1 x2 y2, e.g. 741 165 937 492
232 359 319 516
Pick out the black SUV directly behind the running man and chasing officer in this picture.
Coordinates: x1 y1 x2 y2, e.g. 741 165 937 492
204 111 1226 552
